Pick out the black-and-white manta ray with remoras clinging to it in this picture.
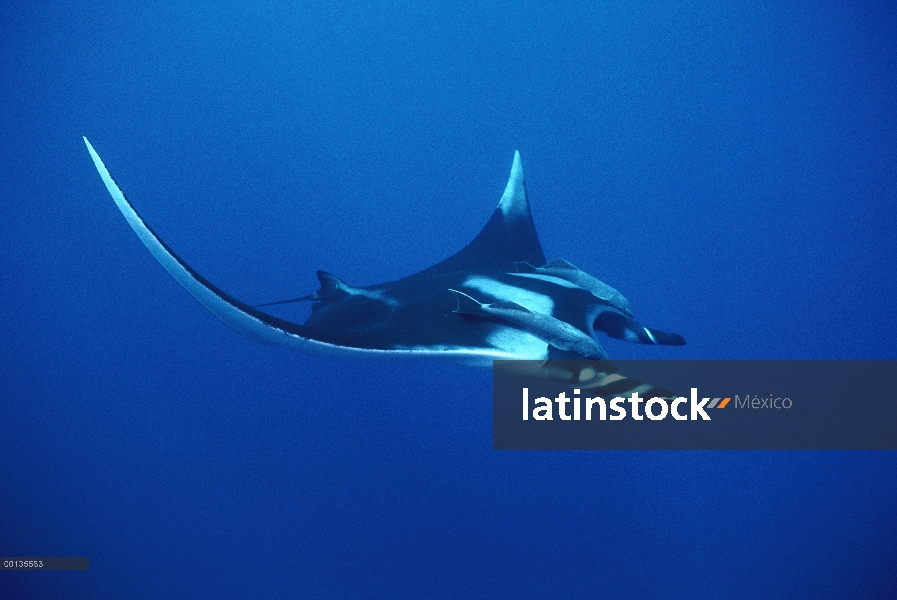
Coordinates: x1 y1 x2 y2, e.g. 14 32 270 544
84 138 685 366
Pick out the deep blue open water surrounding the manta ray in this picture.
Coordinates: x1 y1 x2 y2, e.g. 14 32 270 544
0 1 897 598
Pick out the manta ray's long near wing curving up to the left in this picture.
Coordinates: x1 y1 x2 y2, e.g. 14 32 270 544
84 138 505 362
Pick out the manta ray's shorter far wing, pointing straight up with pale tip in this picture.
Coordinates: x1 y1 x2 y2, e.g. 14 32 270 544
406 151 545 279
